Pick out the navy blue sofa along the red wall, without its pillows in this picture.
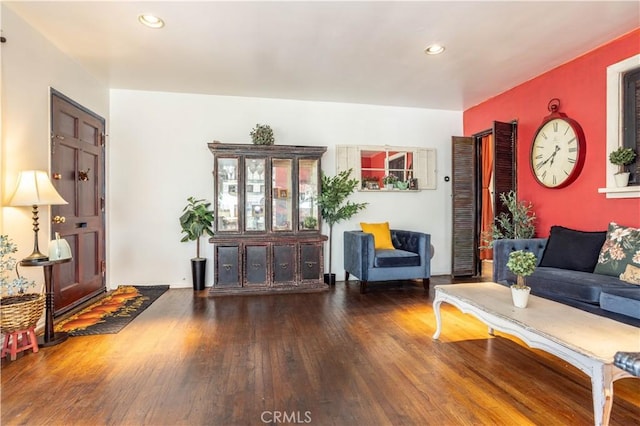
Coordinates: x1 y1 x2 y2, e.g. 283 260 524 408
493 238 640 327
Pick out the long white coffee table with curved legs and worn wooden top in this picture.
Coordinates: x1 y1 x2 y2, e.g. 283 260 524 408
433 282 640 426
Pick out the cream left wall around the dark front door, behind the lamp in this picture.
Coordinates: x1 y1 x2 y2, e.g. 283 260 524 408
0 4 109 283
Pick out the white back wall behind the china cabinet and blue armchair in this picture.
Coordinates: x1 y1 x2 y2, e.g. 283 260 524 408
107 89 462 288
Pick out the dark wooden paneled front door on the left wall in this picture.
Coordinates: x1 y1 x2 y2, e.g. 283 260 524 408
51 90 106 315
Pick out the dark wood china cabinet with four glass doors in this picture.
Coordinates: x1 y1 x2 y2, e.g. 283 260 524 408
208 141 327 294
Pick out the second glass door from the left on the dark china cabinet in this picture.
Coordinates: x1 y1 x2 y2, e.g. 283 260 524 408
244 158 267 231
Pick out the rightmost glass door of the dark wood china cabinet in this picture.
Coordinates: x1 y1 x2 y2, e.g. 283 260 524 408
298 159 319 230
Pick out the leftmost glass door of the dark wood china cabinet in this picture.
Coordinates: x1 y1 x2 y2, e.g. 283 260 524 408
216 158 238 231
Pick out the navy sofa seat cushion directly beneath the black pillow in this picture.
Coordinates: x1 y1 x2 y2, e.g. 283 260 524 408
526 267 630 305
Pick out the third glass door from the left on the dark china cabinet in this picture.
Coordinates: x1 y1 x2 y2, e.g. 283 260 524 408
271 158 293 231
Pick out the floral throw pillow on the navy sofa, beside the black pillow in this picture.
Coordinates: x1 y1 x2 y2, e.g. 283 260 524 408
593 222 640 277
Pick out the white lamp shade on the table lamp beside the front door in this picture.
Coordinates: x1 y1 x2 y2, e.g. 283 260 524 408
9 170 68 207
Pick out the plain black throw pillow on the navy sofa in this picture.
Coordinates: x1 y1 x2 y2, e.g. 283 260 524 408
538 226 607 272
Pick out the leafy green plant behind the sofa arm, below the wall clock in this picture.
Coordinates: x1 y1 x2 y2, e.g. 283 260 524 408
482 190 536 248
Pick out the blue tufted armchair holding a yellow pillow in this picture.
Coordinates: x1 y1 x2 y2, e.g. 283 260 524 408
344 229 431 293
